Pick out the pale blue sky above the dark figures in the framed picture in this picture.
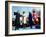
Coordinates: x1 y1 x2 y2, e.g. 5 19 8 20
12 6 40 18
